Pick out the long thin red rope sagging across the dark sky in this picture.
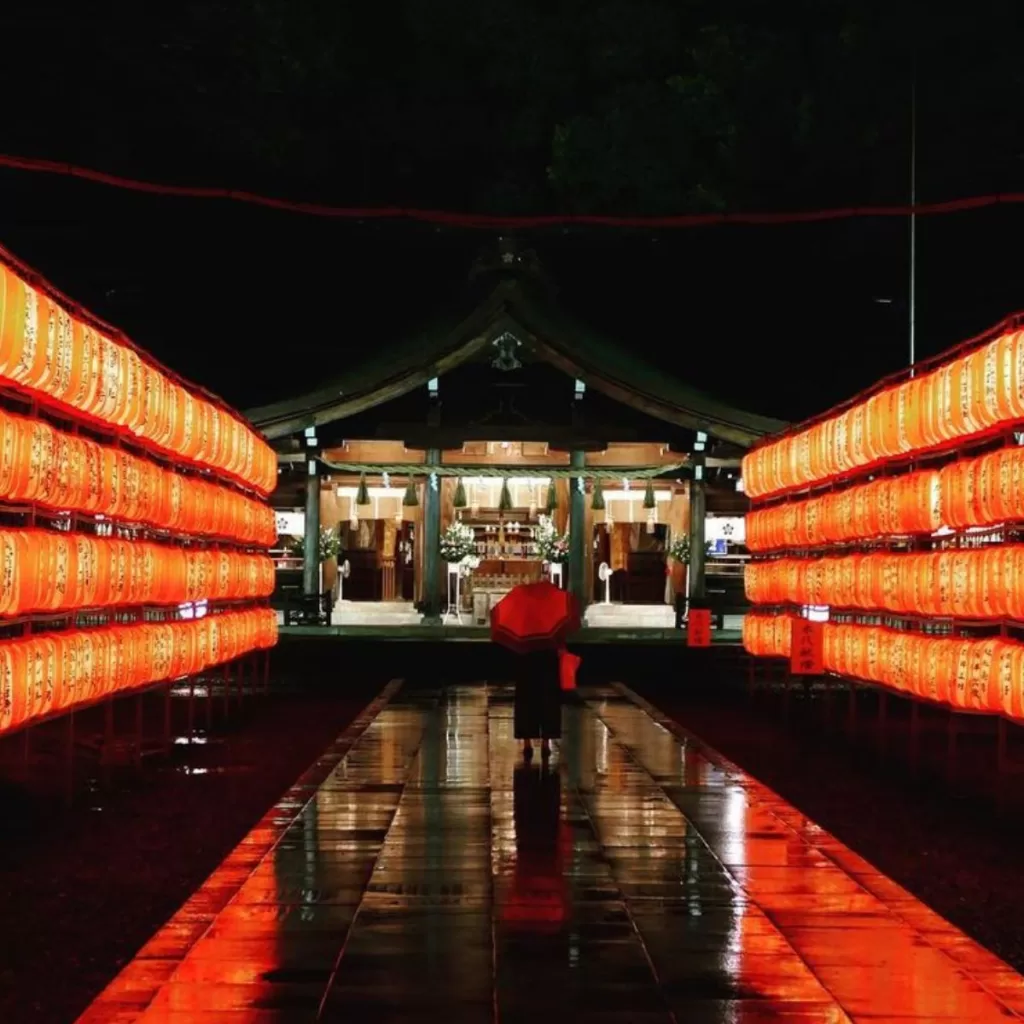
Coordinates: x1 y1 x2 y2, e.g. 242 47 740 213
6 155 1024 230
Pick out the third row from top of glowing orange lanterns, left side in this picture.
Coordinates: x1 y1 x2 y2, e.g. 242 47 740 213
0 529 274 616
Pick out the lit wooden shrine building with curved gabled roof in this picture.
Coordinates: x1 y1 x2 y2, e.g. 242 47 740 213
248 241 782 631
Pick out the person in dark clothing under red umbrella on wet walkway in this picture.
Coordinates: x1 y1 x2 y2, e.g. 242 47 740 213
490 581 580 761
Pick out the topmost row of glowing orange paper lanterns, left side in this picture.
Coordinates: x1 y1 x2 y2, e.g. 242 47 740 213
0 264 278 495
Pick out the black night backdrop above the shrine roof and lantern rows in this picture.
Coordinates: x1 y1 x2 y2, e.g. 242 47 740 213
0 0 1024 419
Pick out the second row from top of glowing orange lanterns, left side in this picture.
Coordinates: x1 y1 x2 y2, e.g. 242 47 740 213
0 410 278 547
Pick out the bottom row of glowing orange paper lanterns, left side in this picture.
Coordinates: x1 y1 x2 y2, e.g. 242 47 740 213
0 608 278 734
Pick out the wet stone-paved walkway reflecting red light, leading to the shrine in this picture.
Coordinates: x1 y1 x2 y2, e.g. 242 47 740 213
80 684 1024 1024
